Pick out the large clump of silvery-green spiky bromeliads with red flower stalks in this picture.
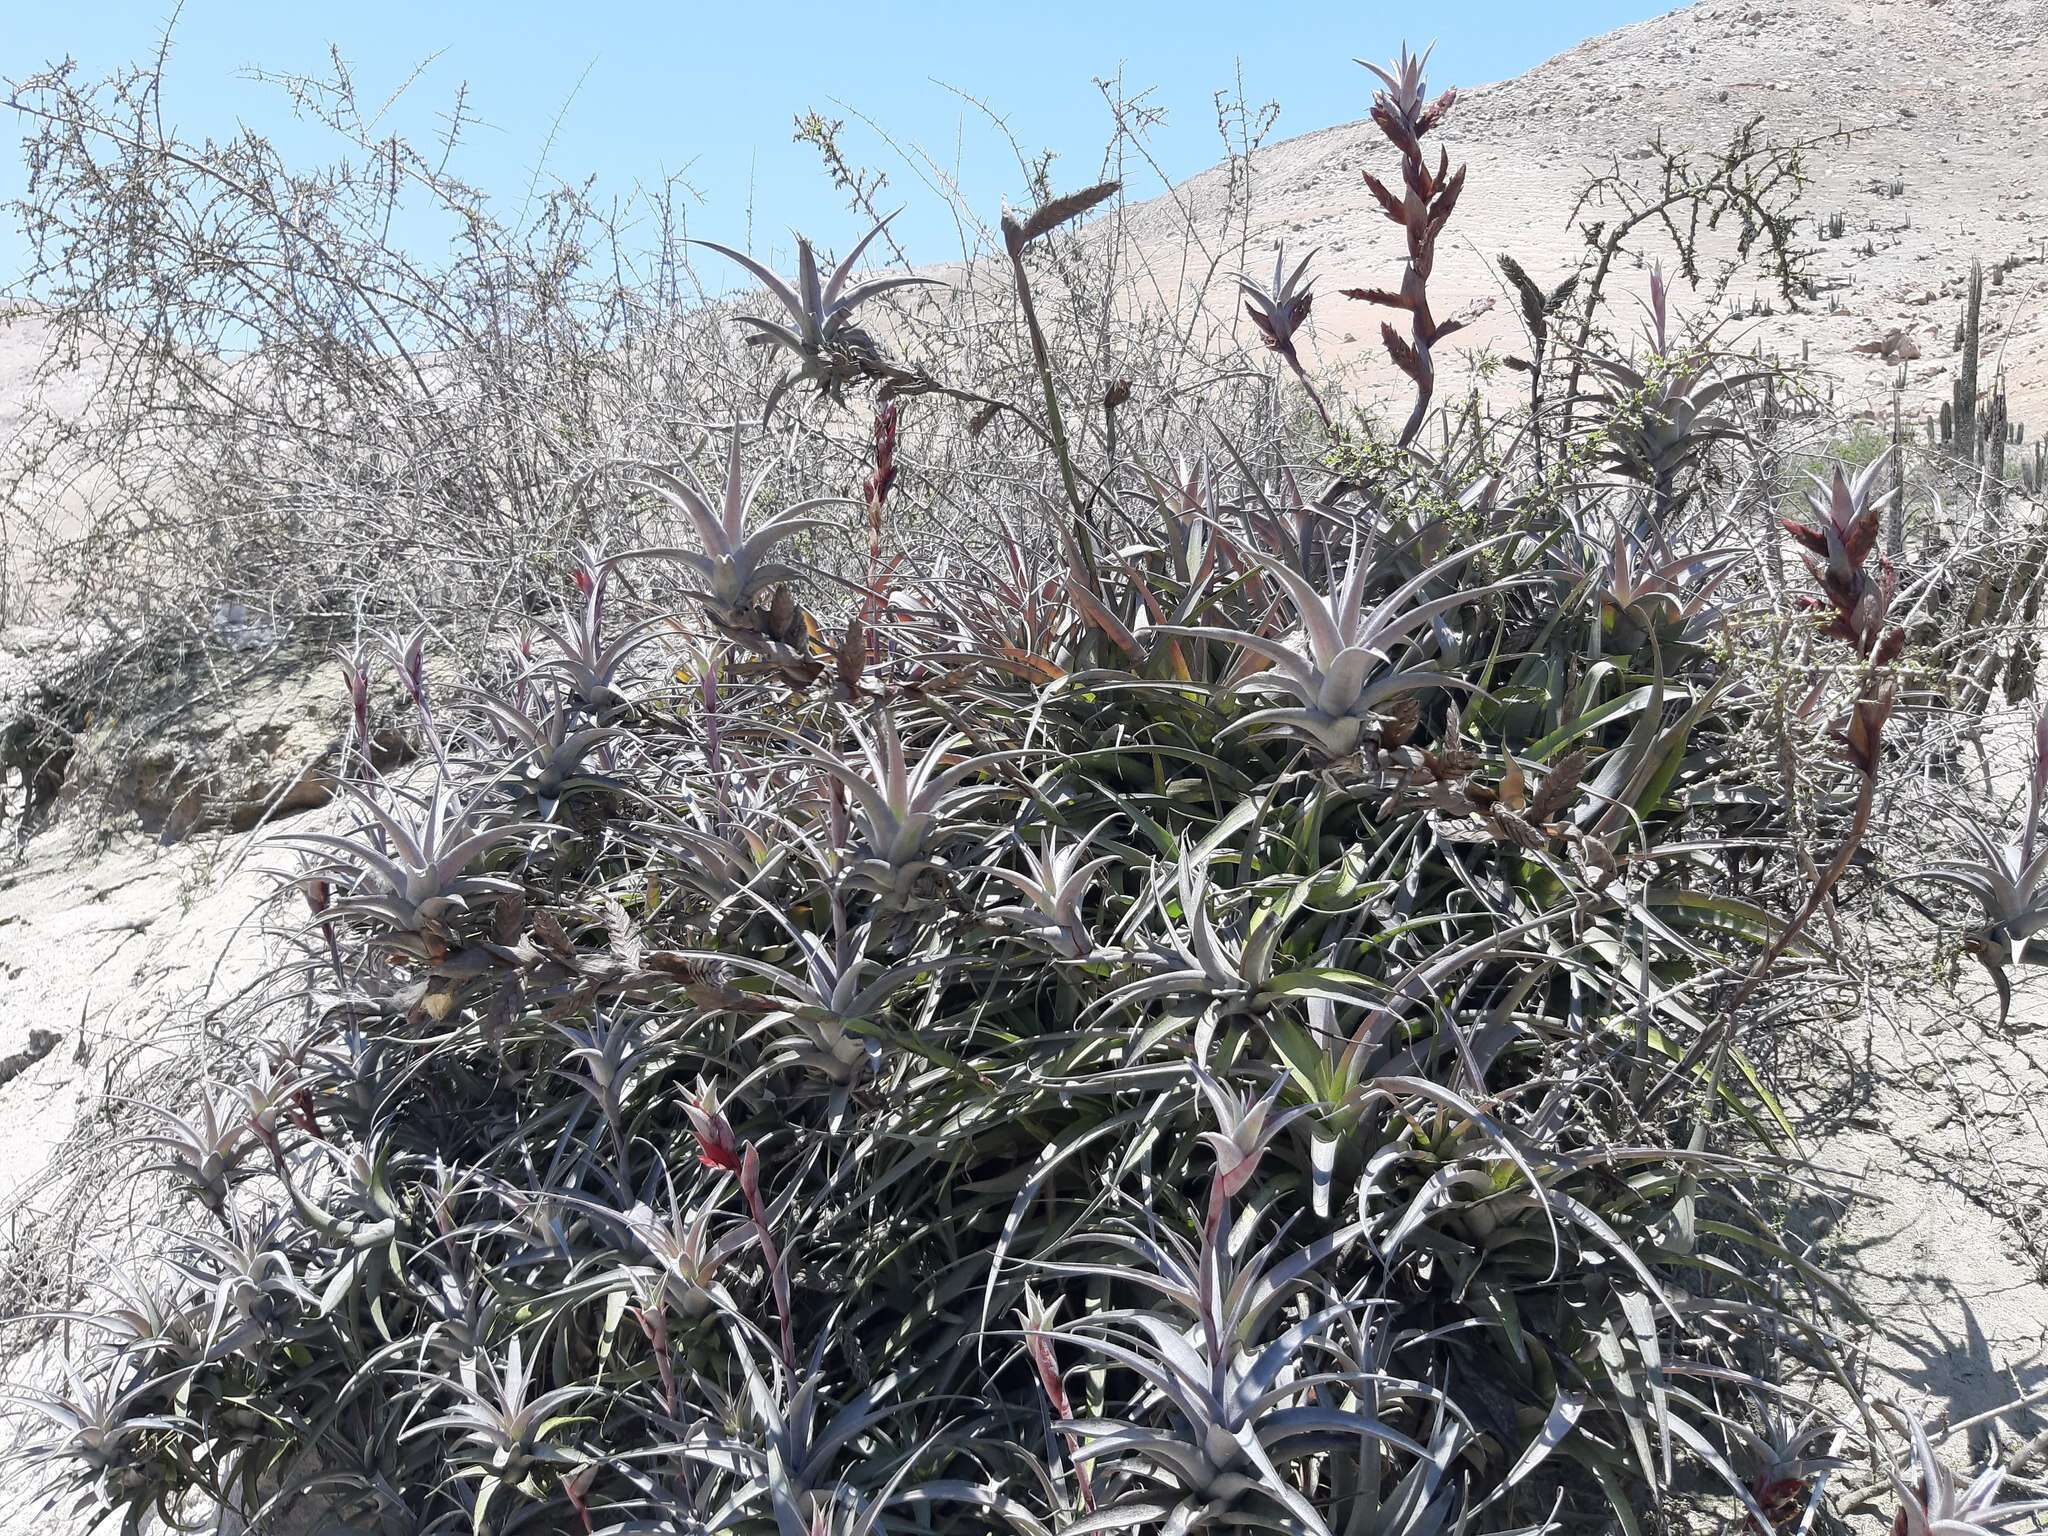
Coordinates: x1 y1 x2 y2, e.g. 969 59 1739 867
16 41 2048 1536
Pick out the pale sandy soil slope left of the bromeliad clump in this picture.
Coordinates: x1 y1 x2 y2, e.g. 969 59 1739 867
0 825 288 1536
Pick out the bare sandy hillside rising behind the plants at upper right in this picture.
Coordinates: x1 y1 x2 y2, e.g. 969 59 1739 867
1137 0 2048 440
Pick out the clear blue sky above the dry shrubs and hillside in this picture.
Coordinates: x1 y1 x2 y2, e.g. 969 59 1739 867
0 0 1665 281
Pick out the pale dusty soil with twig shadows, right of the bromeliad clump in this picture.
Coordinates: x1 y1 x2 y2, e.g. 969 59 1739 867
1792 711 2048 1520
